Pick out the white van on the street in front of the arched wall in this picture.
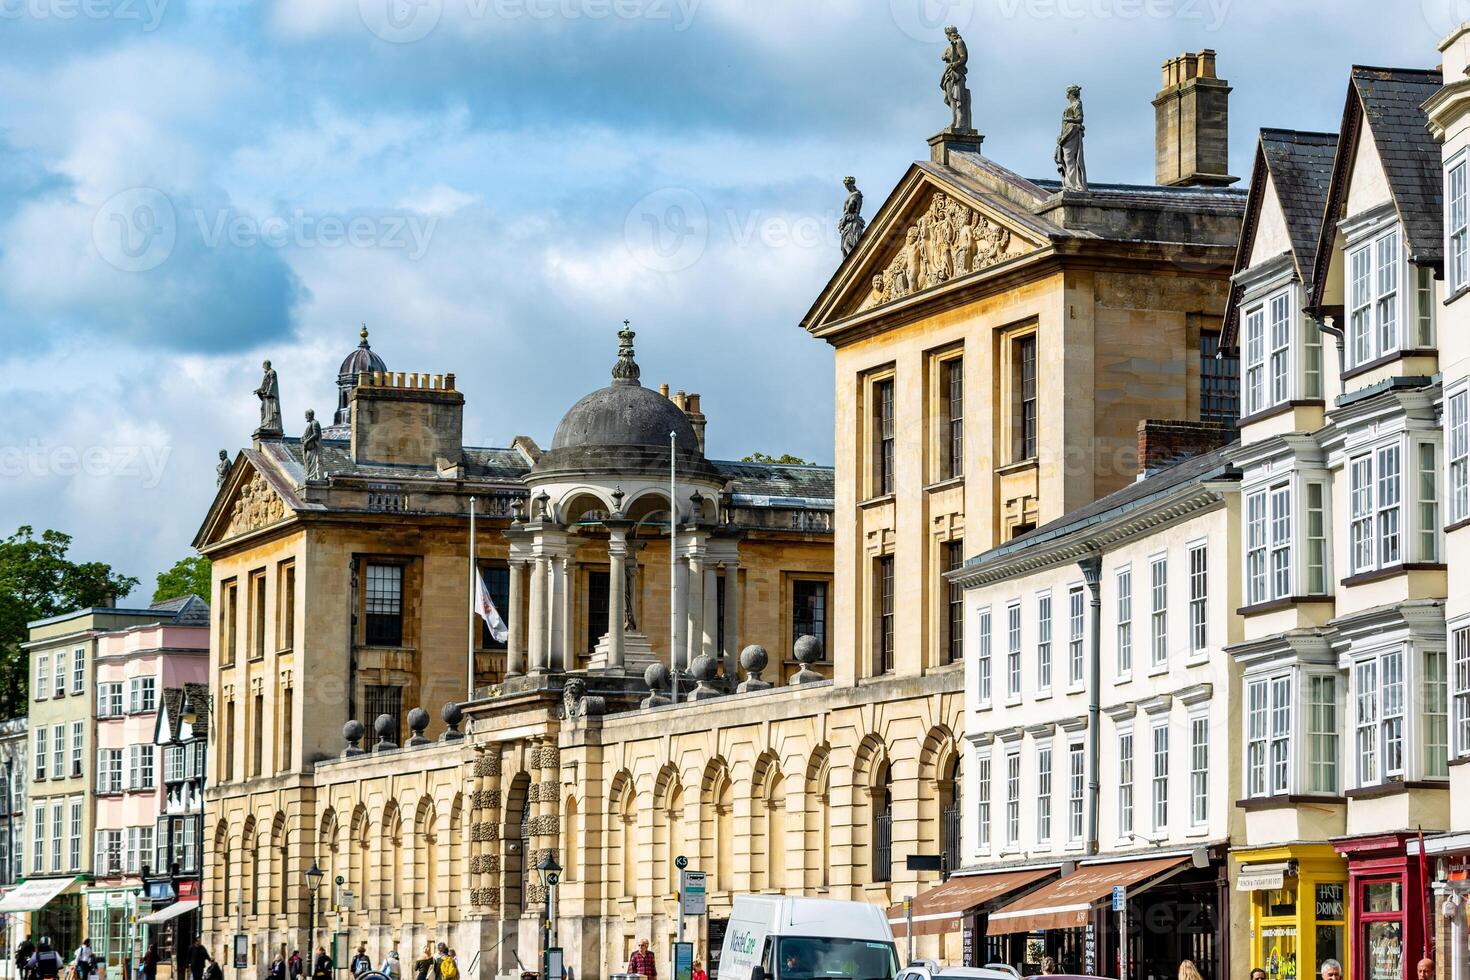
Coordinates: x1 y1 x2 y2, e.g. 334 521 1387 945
719 895 898 980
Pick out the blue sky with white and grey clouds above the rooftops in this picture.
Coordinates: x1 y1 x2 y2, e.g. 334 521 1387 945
0 0 1452 599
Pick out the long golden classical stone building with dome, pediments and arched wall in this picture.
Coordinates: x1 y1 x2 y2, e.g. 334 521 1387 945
197 53 1244 977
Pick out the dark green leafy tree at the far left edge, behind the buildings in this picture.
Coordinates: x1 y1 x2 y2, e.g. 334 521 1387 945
0 525 138 717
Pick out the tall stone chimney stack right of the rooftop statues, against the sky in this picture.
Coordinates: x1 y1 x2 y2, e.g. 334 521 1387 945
1154 48 1239 187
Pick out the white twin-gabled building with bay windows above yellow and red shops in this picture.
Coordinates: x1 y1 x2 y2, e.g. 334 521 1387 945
1226 68 1449 979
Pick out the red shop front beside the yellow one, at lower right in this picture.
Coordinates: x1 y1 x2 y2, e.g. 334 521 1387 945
1332 833 1429 980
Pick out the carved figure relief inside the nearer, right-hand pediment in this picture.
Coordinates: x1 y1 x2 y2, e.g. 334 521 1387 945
857 190 1035 311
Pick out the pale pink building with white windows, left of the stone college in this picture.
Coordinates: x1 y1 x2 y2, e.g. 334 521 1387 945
87 597 209 979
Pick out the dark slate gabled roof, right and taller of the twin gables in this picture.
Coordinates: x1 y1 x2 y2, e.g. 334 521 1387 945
1310 65 1445 307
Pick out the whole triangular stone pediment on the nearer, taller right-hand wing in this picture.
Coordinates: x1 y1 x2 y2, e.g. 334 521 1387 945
806 166 1047 331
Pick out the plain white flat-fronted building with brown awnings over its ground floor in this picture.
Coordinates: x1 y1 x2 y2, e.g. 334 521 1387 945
946 440 1247 979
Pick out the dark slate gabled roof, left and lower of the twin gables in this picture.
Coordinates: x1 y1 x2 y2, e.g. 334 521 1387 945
1220 128 1338 350
